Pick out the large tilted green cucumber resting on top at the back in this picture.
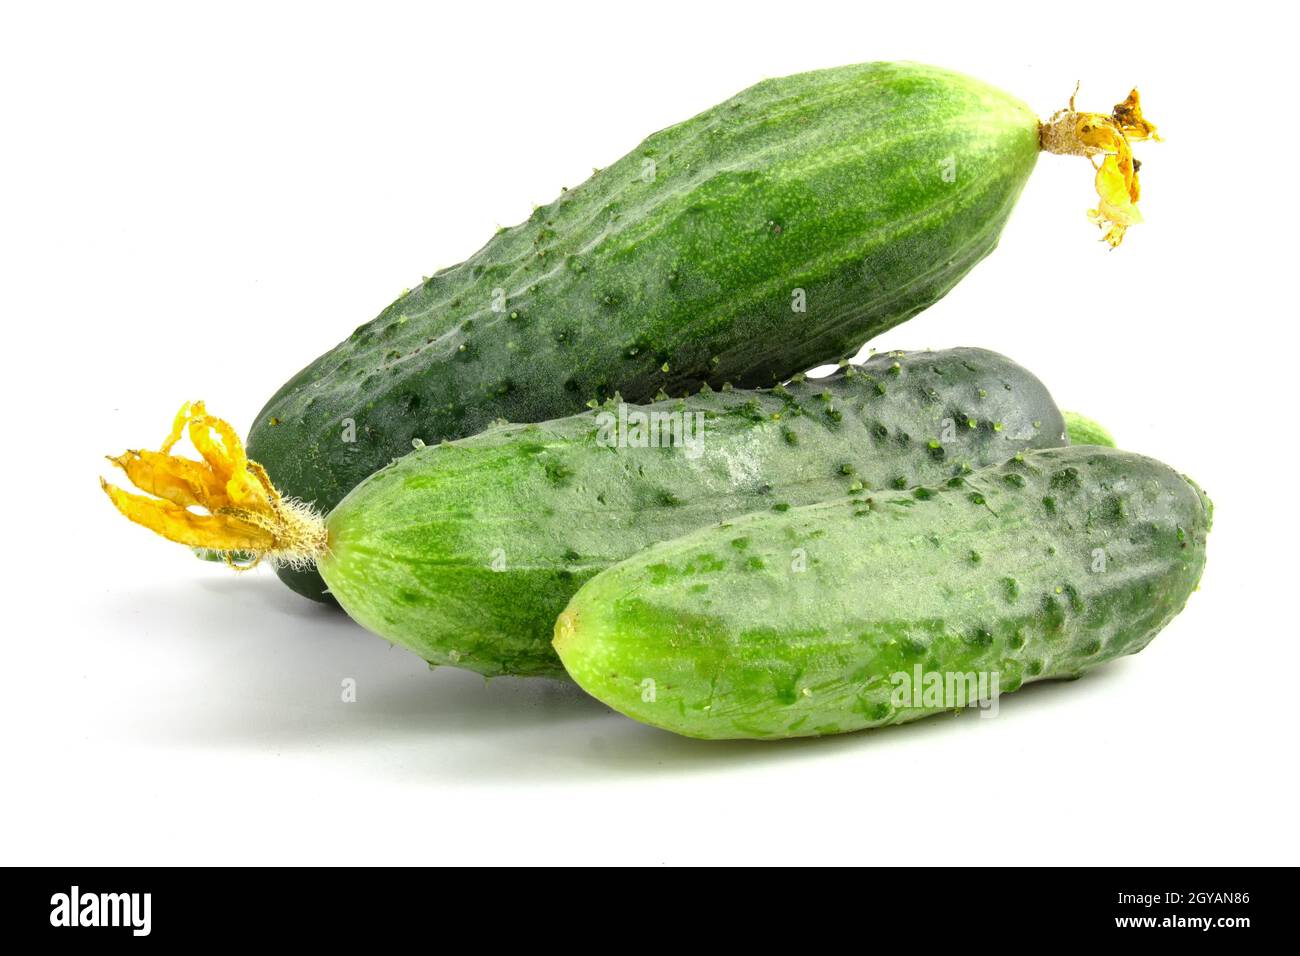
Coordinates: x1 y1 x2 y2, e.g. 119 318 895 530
248 64 1039 597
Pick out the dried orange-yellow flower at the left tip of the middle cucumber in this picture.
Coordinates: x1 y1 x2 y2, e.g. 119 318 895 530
99 402 329 571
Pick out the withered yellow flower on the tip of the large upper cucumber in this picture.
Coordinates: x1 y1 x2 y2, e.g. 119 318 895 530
1039 87 1160 248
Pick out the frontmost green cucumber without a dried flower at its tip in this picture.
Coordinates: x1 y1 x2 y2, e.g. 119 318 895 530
555 446 1212 737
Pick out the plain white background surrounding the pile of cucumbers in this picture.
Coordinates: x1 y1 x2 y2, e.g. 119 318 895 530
0 0 1300 866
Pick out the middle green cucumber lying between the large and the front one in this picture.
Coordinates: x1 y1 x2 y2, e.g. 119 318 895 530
321 349 1065 676
